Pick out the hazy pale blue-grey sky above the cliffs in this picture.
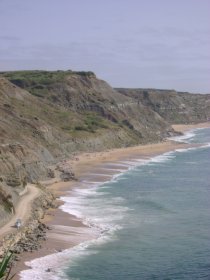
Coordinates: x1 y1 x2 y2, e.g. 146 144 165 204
0 0 210 93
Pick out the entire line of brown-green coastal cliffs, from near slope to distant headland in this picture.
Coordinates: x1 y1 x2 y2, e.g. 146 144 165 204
0 71 210 225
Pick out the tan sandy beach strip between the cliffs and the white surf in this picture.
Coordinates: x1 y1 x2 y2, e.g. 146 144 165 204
9 123 210 280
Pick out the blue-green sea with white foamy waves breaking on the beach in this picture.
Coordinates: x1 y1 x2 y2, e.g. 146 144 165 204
21 128 210 280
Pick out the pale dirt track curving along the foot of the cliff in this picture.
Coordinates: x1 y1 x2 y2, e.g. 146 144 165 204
0 184 40 240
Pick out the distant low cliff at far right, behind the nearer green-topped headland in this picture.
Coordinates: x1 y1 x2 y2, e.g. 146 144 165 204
116 89 210 124
